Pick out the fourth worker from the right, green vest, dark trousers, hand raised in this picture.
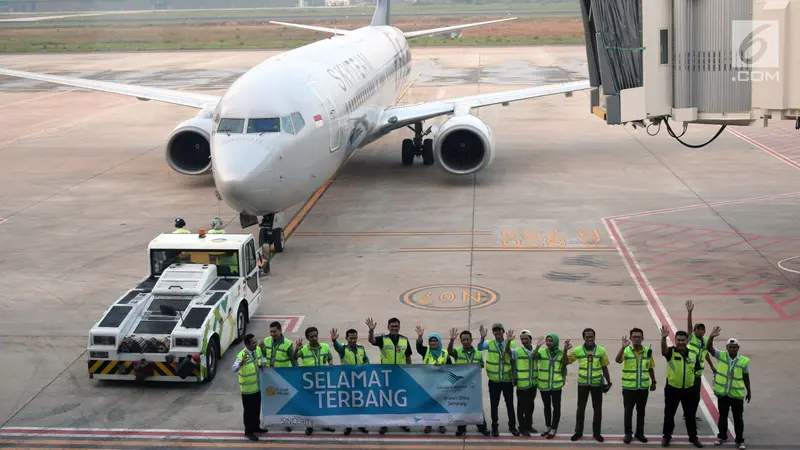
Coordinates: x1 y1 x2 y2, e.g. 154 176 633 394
615 328 656 444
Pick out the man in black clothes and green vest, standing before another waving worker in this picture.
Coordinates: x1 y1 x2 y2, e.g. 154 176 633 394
661 327 703 448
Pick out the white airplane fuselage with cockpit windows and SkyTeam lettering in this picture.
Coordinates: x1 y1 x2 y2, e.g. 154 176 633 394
211 26 411 216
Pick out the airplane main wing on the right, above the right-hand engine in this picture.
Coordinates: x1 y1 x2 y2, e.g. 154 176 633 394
380 81 592 132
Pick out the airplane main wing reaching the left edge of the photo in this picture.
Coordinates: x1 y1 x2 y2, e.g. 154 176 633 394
0 68 221 109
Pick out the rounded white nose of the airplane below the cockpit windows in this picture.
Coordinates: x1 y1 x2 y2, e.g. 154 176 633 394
213 136 275 213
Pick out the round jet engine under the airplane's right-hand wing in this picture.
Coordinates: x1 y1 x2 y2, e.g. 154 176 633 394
433 114 494 175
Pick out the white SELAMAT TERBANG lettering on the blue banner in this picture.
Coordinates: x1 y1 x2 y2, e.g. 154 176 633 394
303 370 407 409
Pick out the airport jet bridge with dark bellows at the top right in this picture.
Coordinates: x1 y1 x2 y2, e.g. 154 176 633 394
579 0 800 148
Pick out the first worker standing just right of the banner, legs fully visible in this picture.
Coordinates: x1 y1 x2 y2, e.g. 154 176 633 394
478 323 519 437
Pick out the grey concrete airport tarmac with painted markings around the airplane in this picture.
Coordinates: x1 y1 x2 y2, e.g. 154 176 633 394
0 46 800 449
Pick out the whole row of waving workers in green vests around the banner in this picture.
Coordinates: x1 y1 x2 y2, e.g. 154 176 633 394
232 301 751 449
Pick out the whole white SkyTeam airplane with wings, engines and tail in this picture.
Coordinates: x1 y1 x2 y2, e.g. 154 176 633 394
0 0 591 252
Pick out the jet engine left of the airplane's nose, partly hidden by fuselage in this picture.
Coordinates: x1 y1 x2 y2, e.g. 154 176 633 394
167 117 212 175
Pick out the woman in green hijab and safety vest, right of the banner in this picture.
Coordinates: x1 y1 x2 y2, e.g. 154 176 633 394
534 333 571 439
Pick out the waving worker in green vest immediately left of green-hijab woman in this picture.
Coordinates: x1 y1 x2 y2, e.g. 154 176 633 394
506 330 539 436
